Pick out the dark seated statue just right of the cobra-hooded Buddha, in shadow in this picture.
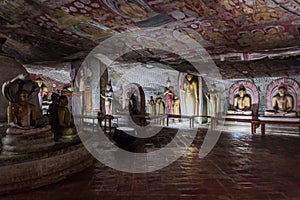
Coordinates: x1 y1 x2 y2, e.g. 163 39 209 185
57 95 76 138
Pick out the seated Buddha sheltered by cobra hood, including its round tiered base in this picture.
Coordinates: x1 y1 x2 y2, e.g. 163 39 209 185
2 75 54 155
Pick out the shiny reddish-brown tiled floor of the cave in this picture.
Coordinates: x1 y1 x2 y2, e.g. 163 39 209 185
0 127 300 200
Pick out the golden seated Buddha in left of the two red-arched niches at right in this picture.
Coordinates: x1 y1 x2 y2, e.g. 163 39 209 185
227 85 252 115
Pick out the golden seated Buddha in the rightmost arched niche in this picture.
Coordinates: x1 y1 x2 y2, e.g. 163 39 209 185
265 84 297 117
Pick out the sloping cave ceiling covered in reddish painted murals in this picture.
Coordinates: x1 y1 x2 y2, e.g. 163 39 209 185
0 0 300 78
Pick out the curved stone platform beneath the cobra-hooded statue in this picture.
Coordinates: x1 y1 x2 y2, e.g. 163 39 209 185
0 140 94 196
